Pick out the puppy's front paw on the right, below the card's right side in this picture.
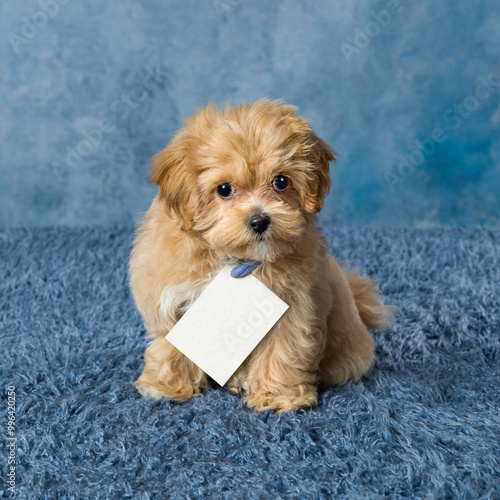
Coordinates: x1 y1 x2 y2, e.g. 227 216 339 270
244 384 318 413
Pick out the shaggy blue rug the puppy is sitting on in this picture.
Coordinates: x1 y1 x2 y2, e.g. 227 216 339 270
0 227 500 499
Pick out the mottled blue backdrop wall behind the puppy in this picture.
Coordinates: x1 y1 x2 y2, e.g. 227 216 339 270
0 0 500 226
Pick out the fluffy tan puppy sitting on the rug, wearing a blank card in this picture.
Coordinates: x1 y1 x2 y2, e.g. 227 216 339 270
130 100 392 412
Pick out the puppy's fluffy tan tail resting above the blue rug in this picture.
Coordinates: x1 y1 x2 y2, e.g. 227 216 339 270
347 271 397 330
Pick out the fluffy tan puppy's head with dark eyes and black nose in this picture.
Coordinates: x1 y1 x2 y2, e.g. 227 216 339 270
149 100 335 261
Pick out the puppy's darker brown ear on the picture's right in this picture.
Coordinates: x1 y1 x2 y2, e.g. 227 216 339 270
302 132 336 214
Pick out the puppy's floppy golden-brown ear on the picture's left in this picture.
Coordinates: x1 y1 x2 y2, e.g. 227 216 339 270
147 133 198 230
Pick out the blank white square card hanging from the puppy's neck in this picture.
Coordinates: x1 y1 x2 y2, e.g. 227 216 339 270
165 265 288 385
